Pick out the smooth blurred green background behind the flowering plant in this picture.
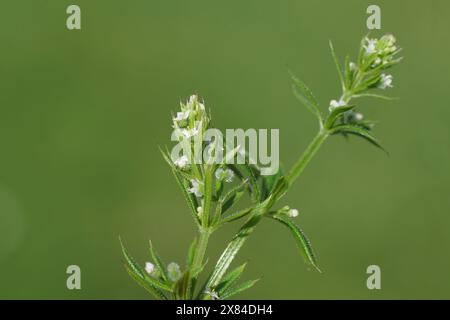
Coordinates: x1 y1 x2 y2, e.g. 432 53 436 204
0 0 450 299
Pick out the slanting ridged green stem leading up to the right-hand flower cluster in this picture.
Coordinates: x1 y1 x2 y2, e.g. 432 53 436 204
206 128 329 288
